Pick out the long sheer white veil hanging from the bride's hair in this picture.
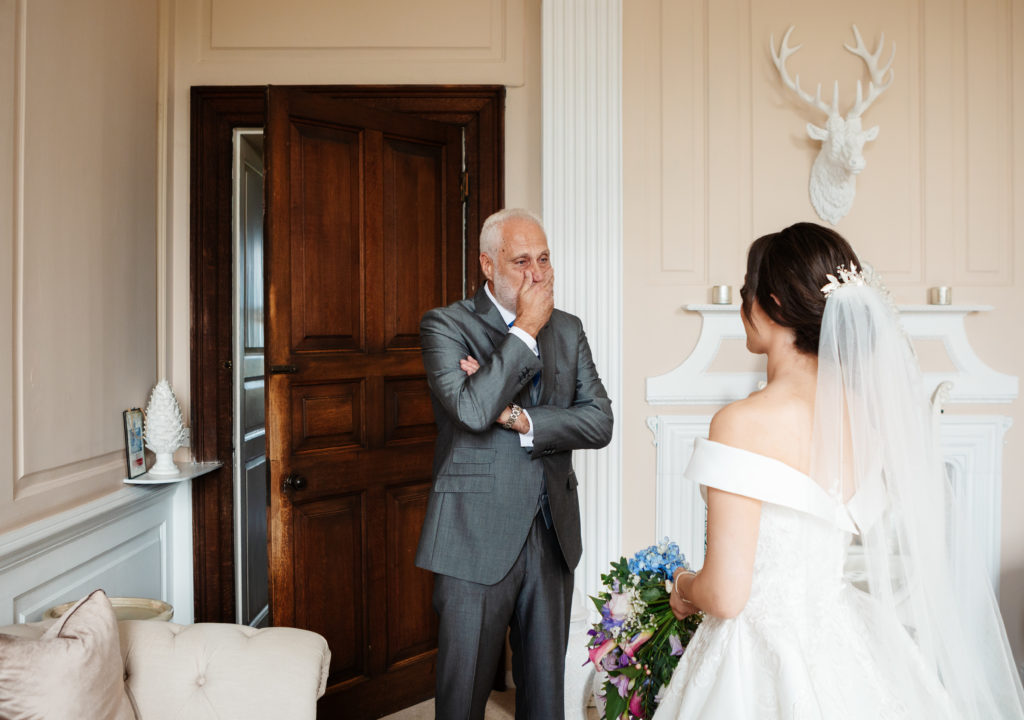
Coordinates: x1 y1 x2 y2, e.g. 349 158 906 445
808 269 1024 720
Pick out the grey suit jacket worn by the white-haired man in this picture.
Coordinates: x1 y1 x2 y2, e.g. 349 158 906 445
416 286 612 585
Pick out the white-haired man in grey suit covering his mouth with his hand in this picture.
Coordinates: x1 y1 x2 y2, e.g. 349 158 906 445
416 210 612 720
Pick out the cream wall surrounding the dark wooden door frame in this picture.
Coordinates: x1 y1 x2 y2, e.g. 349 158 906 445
160 0 541 428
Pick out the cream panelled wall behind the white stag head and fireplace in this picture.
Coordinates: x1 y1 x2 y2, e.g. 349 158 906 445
621 0 1024 657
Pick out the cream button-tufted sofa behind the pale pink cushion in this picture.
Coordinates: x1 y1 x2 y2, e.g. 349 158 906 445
0 620 331 720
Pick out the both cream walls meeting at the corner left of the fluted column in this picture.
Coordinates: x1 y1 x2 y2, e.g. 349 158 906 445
0 0 541 544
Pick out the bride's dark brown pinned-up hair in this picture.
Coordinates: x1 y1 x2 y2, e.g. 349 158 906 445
739 222 860 355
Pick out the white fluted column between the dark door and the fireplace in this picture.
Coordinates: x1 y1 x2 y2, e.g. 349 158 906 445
542 0 623 594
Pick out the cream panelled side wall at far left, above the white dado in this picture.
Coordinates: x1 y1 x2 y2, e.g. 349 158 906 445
0 0 158 531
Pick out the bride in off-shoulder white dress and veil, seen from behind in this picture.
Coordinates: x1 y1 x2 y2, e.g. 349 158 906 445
654 223 1024 720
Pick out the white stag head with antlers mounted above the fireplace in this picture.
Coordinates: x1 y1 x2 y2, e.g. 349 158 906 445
771 26 896 225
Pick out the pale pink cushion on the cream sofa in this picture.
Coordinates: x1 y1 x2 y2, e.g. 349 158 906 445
0 590 135 720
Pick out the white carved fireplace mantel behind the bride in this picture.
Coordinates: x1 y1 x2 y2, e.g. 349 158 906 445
647 305 1018 587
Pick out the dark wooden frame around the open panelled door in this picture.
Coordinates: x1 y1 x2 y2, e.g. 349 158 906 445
189 85 505 623
